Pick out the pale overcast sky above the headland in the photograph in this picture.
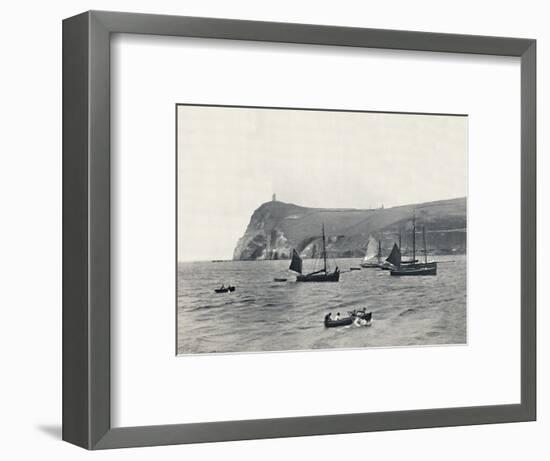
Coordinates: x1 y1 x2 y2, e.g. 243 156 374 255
177 106 468 261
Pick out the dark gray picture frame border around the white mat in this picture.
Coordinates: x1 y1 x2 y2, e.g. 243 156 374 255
63 11 536 449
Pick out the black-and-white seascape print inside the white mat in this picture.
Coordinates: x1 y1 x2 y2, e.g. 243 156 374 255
176 104 468 355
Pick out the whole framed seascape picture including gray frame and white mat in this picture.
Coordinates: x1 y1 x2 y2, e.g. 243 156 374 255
63 11 536 449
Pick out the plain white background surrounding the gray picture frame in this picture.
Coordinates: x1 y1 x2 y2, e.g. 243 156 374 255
0 0 550 461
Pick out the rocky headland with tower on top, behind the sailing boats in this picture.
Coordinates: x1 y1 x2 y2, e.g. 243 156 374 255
233 198 467 260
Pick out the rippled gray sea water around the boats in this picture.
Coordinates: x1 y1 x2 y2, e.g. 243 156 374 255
178 255 466 354
